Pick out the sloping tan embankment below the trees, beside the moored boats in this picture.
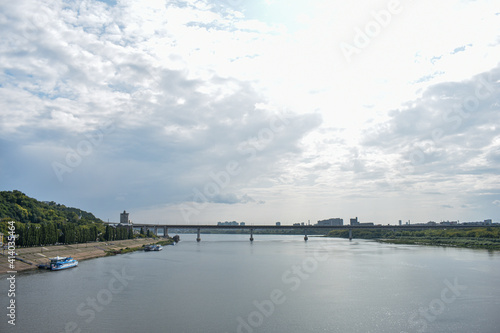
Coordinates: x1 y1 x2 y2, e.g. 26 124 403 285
0 238 161 274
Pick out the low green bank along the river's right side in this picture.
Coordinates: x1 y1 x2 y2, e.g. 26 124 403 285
327 227 500 250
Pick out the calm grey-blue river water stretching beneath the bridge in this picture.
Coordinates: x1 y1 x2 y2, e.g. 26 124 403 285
0 235 500 333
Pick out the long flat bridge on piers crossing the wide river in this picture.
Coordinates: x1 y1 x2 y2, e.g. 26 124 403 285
132 224 500 242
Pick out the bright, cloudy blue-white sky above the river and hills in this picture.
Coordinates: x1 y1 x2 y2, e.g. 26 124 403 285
0 0 500 224
